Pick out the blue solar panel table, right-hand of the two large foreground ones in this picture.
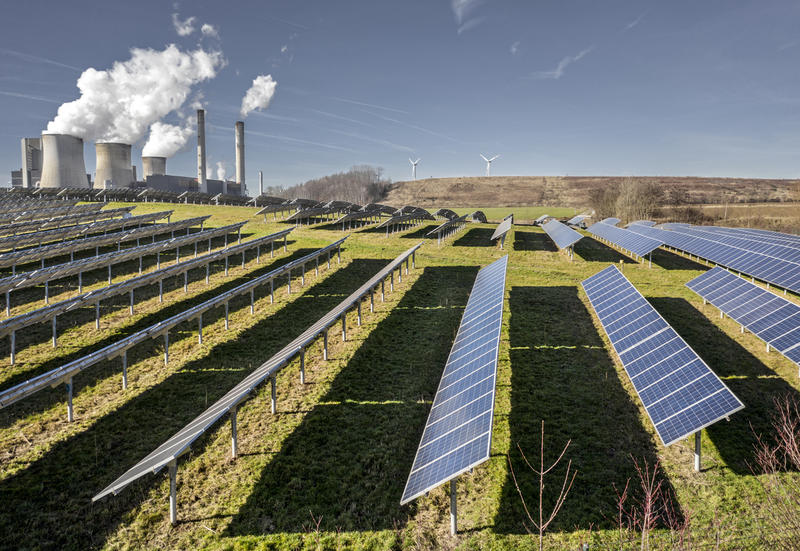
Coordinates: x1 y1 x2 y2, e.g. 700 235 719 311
582 266 744 446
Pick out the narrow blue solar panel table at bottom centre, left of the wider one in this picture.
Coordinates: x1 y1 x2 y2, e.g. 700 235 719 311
400 256 508 504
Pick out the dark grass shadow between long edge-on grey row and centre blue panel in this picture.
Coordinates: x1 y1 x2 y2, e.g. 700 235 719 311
226 266 478 536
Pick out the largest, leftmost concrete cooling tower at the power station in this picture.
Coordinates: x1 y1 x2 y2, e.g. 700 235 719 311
39 134 89 188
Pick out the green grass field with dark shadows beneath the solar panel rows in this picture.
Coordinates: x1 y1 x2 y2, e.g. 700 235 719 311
0 204 798 549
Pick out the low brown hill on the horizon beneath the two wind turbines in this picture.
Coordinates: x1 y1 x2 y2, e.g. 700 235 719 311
384 176 800 208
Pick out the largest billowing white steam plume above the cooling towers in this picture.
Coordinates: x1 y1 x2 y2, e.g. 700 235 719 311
47 44 225 143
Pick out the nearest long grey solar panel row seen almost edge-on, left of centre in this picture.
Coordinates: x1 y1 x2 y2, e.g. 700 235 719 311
92 238 422 501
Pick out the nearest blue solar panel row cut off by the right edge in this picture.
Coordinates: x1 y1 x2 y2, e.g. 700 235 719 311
686 267 800 365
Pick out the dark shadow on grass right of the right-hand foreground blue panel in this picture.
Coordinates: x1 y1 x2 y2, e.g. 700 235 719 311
649 297 800 475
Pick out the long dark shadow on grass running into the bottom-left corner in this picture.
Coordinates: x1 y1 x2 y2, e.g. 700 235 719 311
0 259 386 549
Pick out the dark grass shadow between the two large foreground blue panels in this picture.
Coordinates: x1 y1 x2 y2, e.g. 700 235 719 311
494 286 671 534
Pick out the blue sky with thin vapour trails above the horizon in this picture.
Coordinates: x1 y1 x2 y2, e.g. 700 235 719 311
0 0 800 191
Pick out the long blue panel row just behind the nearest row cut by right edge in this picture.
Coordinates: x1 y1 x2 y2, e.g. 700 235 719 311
629 224 800 293
